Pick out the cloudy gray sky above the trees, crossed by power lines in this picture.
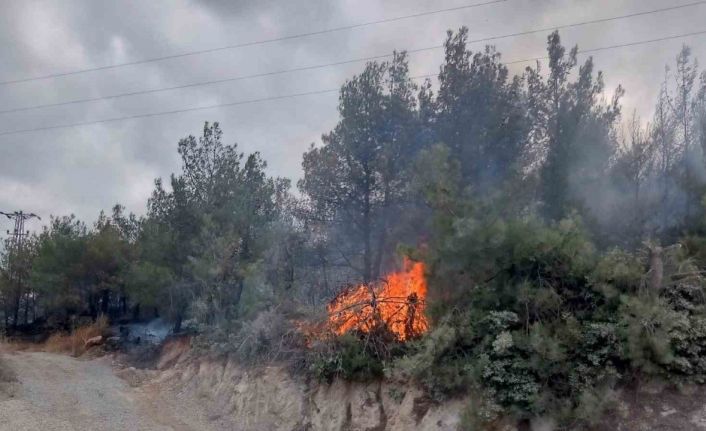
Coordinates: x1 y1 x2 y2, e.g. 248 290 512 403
0 0 706 232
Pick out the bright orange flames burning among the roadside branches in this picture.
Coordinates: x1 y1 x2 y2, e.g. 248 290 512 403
327 259 429 341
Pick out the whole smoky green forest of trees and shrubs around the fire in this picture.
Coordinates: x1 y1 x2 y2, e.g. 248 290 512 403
0 28 706 429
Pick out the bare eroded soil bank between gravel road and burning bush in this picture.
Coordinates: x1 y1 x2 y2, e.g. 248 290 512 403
147 359 464 431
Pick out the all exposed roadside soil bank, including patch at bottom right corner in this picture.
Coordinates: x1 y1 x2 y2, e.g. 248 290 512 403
119 339 706 431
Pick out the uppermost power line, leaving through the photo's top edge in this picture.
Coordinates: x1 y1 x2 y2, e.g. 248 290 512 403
0 0 509 86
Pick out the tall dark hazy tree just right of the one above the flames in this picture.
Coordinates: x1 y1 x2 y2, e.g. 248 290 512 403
436 27 528 192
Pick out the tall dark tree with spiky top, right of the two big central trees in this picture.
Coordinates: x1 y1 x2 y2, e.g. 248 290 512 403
527 32 623 220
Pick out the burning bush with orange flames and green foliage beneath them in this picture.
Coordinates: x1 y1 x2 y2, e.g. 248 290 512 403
300 259 429 381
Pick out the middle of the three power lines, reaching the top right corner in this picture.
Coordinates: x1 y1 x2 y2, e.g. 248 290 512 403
0 0 706 115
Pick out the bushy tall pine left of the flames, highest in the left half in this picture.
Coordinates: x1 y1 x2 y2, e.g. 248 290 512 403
135 123 280 329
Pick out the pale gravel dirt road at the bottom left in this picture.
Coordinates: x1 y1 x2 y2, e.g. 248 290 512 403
0 352 219 431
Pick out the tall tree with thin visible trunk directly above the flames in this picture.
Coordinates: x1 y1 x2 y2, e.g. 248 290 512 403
299 53 418 282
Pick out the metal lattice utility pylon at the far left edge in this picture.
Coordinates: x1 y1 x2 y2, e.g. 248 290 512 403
0 211 42 328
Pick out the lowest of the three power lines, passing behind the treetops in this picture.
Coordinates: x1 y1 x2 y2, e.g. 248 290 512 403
0 30 706 136
